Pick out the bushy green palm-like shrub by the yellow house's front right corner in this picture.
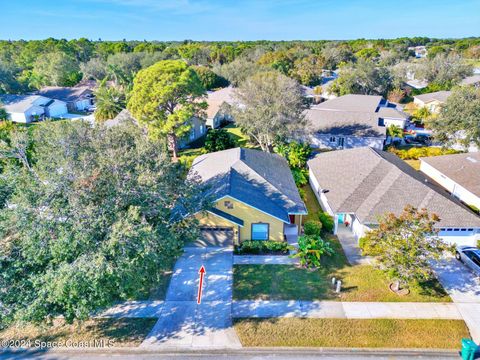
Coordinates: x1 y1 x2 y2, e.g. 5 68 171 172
293 235 334 267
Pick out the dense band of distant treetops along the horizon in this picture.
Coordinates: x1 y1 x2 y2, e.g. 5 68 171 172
0 37 480 92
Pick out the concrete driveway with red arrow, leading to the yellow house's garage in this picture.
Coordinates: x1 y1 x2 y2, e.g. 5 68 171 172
141 247 241 349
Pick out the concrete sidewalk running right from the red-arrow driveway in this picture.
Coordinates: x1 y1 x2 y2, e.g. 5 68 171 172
232 300 464 320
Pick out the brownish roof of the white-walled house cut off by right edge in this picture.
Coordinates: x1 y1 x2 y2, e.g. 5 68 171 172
420 153 480 196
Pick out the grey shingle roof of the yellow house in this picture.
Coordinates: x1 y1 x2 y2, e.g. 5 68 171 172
189 148 306 222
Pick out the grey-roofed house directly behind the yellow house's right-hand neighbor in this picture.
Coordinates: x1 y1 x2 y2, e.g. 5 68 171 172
305 95 409 149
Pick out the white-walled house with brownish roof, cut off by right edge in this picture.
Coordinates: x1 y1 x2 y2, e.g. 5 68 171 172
420 153 480 209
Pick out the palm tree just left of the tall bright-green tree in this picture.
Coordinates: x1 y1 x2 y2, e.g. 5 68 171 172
94 82 126 121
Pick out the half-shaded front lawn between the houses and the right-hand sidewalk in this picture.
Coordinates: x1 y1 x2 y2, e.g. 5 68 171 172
233 265 451 302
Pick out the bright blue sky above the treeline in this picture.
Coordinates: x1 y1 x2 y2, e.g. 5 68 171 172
0 0 480 40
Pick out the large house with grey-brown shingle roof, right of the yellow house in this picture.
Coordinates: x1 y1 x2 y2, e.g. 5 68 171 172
308 147 480 245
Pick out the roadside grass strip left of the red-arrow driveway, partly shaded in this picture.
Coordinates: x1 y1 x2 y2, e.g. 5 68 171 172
0 318 158 347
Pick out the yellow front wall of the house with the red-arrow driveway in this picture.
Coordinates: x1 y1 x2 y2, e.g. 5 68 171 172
196 197 284 241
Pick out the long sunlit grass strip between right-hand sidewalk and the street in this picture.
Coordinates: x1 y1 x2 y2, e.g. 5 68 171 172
234 318 470 349
